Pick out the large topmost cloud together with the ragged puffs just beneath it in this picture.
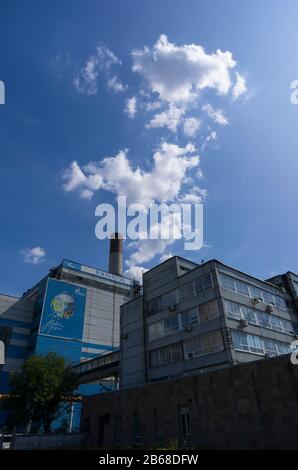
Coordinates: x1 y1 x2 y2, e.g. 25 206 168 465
132 34 247 138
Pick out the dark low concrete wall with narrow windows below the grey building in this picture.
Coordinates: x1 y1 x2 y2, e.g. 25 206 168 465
82 355 298 449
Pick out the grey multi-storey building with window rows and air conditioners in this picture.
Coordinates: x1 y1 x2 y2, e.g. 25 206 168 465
120 257 298 389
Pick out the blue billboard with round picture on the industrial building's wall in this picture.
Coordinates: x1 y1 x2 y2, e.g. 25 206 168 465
39 279 87 340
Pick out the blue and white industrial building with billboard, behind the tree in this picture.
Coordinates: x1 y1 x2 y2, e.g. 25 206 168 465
0 259 135 427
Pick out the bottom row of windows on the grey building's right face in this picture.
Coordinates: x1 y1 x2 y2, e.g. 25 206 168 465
232 330 291 356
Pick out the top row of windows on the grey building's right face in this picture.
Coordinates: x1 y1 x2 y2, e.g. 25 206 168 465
220 273 287 310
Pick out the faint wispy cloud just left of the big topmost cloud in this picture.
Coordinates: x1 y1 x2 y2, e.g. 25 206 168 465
73 46 124 96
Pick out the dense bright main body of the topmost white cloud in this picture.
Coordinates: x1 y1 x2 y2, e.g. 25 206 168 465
132 35 236 103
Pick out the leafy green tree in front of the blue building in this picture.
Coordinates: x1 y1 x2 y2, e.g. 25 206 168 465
3 353 78 432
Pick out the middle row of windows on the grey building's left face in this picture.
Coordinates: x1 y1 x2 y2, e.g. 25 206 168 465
149 300 219 341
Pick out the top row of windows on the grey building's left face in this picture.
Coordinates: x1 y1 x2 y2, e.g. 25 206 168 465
147 273 213 314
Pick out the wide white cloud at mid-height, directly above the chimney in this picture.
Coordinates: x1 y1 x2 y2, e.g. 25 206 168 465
63 142 200 207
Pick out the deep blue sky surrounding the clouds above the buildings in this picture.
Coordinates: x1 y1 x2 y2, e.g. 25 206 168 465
0 0 298 294
